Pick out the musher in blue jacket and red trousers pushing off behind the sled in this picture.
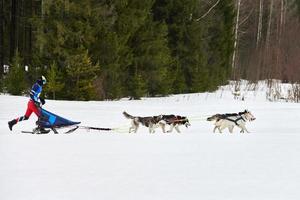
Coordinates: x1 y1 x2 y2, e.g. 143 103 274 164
8 76 46 131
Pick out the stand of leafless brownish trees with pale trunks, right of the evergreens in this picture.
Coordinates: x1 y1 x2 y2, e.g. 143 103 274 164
232 0 300 81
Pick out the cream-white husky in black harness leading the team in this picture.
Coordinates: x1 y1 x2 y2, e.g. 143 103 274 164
207 110 255 133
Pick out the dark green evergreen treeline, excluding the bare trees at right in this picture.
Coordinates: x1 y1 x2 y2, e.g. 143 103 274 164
0 0 236 100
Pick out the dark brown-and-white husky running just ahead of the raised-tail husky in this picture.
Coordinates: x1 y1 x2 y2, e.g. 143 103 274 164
160 115 191 133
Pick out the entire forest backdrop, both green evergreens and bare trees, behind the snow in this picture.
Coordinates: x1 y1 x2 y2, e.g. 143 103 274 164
0 0 300 100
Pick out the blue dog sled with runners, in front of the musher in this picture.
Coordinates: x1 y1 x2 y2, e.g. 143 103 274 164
22 108 113 134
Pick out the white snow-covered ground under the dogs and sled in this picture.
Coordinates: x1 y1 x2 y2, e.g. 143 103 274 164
0 85 300 200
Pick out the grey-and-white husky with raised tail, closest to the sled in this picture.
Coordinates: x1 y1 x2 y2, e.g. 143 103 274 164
123 111 161 133
